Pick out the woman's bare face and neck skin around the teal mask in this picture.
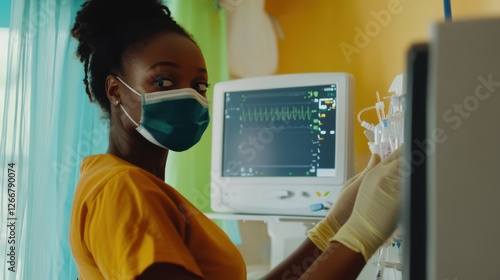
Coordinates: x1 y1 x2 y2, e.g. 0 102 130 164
106 31 208 179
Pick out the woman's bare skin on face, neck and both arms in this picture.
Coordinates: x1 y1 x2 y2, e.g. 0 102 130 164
106 33 365 280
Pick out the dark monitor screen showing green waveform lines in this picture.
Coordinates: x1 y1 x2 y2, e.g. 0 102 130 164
222 84 337 177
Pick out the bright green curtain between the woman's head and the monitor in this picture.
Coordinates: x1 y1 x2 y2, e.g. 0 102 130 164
165 0 241 244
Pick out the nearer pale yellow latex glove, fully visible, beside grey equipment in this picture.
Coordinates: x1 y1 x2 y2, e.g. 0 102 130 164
331 148 403 261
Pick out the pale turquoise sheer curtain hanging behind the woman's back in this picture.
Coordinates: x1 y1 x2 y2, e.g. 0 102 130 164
0 0 108 280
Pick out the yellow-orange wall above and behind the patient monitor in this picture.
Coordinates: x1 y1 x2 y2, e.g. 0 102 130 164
266 0 500 172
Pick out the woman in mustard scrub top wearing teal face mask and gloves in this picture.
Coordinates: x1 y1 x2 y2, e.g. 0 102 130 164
70 0 400 279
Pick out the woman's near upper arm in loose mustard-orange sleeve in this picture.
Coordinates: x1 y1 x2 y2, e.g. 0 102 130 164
86 170 202 280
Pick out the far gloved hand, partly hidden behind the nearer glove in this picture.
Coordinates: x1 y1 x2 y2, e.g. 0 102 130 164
307 154 380 251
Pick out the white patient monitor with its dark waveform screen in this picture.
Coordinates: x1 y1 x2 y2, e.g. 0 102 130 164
211 73 354 216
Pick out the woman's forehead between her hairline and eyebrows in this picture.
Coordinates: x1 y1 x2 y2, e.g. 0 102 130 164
124 33 206 71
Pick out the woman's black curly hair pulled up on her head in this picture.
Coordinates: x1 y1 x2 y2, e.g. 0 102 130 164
71 0 196 117
